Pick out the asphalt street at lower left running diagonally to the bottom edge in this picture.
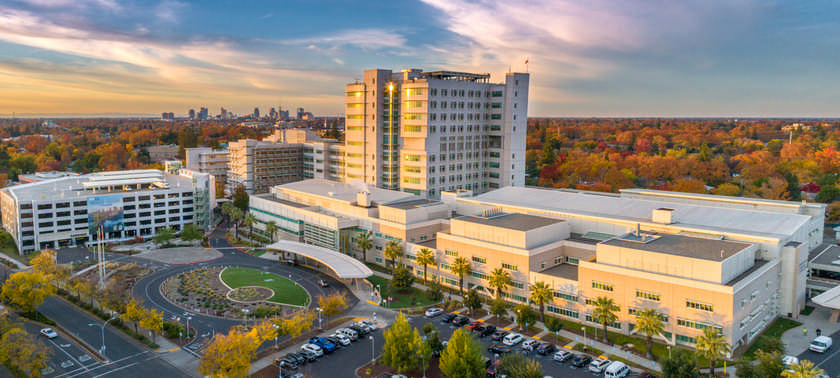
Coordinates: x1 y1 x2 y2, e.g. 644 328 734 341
38 297 189 378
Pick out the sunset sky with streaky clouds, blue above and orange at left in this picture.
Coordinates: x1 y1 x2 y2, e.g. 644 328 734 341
0 0 840 117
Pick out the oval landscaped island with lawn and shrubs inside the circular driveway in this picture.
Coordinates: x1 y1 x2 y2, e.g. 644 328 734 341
161 267 310 318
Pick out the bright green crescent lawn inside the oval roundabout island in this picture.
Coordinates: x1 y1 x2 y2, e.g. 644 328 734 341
222 268 309 306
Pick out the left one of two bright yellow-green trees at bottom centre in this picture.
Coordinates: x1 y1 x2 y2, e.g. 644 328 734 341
382 313 431 373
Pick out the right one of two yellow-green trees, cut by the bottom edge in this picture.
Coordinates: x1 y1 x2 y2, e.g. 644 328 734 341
440 328 485 378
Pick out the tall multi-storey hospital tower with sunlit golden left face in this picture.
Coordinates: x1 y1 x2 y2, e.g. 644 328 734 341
345 69 529 198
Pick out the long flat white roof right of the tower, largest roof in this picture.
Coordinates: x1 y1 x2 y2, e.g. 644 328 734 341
470 186 810 237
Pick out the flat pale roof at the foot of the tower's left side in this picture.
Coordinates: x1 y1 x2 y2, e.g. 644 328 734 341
275 179 420 204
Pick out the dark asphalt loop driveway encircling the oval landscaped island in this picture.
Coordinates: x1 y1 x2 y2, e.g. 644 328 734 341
133 227 358 357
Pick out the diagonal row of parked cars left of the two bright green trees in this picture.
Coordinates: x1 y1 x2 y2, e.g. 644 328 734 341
274 320 376 378
